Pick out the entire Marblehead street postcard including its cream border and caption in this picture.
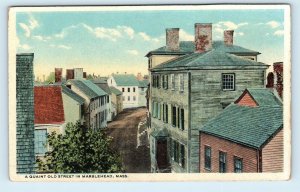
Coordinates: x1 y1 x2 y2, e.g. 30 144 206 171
8 4 291 182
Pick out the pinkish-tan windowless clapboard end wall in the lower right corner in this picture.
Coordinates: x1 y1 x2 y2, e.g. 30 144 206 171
262 129 283 172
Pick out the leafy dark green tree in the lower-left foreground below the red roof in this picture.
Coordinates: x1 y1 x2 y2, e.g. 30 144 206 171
37 123 124 173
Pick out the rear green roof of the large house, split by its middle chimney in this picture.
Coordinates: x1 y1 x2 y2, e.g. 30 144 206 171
146 41 260 57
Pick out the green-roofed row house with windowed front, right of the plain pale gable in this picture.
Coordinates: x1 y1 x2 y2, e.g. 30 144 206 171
67 79 108 130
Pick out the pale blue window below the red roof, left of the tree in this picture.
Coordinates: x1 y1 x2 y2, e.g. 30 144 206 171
34 129 47 155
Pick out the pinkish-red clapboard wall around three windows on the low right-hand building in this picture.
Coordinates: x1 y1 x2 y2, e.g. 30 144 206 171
200 132 258 173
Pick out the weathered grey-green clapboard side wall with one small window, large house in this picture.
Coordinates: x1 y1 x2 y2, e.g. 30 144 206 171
189 69 265 172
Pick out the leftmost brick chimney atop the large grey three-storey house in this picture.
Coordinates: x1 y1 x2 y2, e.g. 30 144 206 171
166 28 179 51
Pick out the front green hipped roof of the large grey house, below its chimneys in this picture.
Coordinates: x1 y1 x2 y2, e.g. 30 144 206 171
153 49 268 71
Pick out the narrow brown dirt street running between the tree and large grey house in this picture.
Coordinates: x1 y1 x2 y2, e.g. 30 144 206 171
107 108 150 173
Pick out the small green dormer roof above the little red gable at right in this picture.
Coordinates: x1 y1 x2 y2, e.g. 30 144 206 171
235 88 282 107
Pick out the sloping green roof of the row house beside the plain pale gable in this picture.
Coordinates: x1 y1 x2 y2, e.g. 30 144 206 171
68 79 107 99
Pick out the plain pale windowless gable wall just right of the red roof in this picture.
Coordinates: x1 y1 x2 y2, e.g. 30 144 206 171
61 85 84 124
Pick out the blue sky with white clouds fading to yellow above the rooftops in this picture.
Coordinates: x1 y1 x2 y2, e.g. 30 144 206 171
16 9 284 78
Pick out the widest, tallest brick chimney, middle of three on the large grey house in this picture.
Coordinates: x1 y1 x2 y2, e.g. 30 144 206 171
195 23 212 53
